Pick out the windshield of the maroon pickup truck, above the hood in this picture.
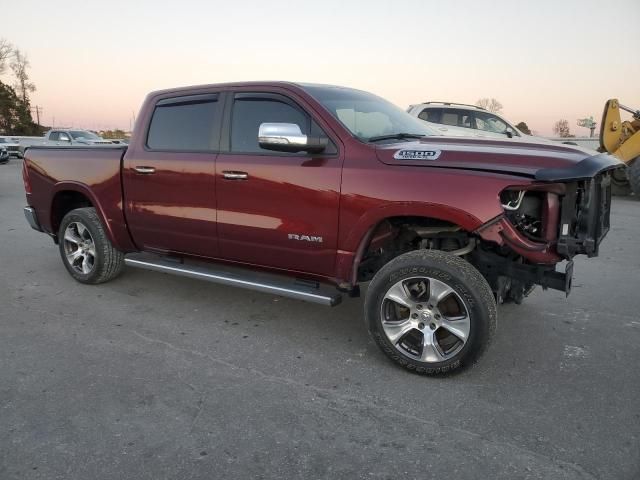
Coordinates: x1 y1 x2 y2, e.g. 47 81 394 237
303 85 437 142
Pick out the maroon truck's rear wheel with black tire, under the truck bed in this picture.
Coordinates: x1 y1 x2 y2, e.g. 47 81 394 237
58 207 124 284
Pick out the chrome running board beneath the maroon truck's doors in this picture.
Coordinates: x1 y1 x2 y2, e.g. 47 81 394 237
124 254 342 307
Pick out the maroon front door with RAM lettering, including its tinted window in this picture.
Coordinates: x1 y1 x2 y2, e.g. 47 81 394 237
216 93 342 275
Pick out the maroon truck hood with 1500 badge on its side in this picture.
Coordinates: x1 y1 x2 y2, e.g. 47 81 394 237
376 137 623 181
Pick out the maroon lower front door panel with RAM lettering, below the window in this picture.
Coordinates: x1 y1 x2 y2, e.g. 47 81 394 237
216 154 341 275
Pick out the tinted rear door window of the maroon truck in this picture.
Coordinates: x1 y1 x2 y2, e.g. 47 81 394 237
147 94 218 151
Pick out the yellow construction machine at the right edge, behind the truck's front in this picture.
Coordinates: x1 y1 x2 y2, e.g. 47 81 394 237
600 98 640 196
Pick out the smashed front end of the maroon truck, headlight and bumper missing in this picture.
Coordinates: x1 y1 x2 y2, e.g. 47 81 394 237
473 155 621 300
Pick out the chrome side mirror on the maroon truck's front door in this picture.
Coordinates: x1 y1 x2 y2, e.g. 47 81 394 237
258 123 328 153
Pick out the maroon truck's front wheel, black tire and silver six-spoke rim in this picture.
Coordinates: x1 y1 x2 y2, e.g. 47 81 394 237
365 250 497 375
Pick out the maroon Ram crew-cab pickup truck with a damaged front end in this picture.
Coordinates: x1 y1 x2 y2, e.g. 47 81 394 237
23 82 621 374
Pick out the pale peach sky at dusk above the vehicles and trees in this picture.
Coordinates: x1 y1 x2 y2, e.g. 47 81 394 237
0 0 640 136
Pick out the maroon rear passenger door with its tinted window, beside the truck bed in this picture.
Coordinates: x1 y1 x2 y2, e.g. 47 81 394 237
123 93 222 257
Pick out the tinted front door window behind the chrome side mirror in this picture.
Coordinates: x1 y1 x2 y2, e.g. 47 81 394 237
231 93 311 153
